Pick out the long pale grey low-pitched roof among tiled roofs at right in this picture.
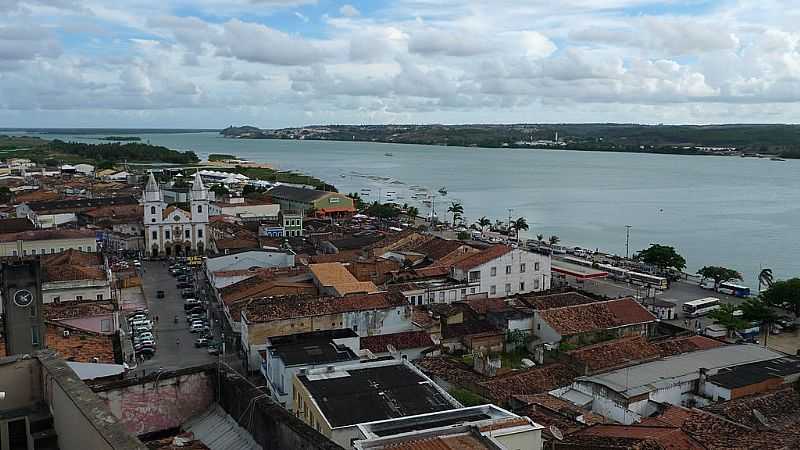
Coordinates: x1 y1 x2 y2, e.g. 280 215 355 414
576 344 784 397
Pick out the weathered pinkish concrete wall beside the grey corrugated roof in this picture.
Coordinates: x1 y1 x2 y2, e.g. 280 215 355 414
97 368 214 435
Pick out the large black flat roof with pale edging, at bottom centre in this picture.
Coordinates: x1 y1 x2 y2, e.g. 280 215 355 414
297 363 457 428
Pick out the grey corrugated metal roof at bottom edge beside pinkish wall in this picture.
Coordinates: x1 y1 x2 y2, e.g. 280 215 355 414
183 405 261 450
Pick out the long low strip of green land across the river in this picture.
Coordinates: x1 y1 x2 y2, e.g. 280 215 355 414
221 124 800 158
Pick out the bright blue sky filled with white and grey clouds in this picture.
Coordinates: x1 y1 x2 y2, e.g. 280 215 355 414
0 0 800 128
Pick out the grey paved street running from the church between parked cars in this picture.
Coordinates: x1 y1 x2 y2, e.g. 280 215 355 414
139 261 217 370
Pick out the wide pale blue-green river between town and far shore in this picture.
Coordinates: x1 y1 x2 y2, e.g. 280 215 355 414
17 133 800 287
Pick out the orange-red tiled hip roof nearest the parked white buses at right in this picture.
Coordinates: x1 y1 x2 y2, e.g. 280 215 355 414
538 298 656 336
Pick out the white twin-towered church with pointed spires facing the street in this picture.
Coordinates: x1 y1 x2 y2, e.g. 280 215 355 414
144 172 208 256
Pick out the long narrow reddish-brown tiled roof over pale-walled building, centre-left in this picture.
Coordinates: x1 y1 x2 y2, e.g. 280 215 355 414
241 292 408 322
